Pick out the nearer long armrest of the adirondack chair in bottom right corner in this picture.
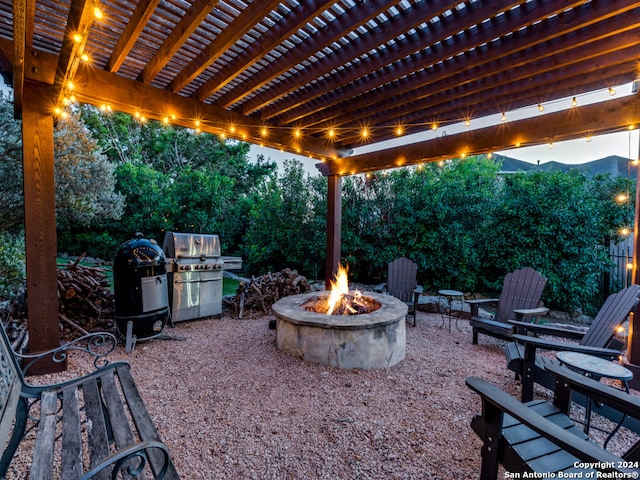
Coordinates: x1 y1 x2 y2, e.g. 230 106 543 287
466 377 620 466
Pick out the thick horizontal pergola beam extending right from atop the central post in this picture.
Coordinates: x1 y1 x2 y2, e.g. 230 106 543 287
317 95 640 176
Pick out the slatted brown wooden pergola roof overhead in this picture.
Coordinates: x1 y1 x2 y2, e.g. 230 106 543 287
0 0 640 172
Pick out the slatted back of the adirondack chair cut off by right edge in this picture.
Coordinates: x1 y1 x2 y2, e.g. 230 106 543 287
580 285 640 348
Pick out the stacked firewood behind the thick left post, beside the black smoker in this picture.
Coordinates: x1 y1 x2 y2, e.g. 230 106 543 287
2 258 116 350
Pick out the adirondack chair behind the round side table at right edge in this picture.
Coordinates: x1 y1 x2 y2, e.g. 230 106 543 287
505 285 640 402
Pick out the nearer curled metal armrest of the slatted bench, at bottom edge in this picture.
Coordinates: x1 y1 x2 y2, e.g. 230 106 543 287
80 440 170 480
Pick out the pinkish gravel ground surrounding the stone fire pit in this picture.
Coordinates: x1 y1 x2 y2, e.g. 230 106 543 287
8 312 631 480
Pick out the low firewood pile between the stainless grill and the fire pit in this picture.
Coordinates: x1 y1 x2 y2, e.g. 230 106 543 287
230 268 311 318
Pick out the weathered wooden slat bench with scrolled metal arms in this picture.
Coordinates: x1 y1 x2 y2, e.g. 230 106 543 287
0 328 178 480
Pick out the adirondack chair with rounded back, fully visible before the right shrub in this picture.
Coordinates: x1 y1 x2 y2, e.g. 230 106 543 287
467 267 548 345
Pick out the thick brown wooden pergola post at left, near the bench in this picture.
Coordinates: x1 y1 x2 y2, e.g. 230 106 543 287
22 81 65 374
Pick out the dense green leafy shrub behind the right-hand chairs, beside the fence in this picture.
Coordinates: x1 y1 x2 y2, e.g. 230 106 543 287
481 170 629 312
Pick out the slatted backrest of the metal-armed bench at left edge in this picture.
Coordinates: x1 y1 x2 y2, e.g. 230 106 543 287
0 325 23 454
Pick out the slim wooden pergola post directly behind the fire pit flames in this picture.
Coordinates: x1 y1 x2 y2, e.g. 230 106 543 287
324 175 342 289
